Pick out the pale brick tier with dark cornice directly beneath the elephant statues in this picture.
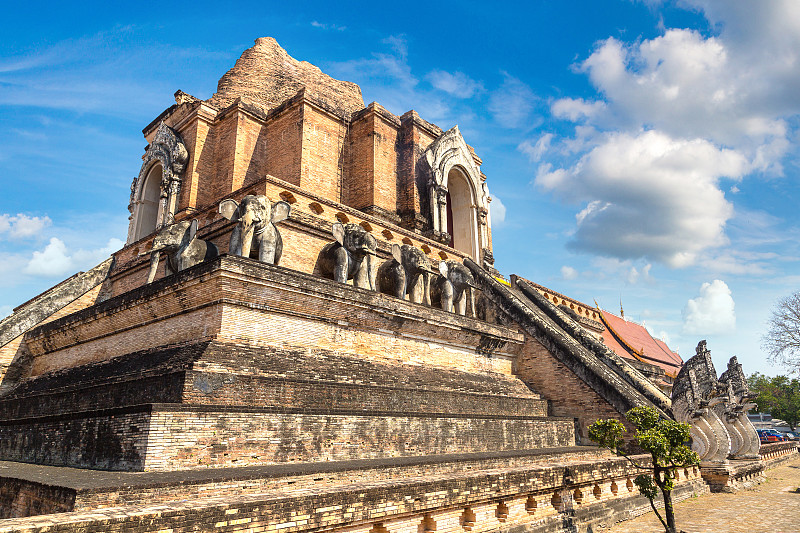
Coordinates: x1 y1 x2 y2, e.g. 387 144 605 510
26 257 522 375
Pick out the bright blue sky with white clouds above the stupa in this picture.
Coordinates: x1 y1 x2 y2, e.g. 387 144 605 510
0 0 800 374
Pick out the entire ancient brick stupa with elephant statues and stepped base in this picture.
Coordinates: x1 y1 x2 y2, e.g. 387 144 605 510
0 38 705 533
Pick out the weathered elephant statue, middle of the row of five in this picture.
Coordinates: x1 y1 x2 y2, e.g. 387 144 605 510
319 222 378 291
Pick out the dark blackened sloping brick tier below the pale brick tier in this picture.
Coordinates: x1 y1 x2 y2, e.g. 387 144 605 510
0 342 547 420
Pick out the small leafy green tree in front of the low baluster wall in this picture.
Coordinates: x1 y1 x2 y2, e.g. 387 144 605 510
589 407 700 533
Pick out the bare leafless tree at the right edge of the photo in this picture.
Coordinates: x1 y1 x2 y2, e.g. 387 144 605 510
761 291 800 372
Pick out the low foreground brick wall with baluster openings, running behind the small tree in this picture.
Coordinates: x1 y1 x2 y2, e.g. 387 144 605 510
0 458 707 533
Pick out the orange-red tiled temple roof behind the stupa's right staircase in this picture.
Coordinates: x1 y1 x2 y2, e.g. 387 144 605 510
600 310 683 378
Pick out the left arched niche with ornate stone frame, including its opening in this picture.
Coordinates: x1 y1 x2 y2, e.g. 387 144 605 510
127 122 189 244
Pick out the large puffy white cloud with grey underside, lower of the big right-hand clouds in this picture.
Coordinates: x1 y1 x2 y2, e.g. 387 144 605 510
535 131 748 267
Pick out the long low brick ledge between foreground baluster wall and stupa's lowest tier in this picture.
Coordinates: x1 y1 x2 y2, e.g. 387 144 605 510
0 446 611 512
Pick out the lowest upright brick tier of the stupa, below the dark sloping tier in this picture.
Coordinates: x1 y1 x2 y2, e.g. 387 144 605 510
0 404 575 471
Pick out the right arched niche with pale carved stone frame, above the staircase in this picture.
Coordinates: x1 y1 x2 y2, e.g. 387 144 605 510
423 126 494 264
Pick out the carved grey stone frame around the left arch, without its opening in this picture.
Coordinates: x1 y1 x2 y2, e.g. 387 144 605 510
128 122 189 243
